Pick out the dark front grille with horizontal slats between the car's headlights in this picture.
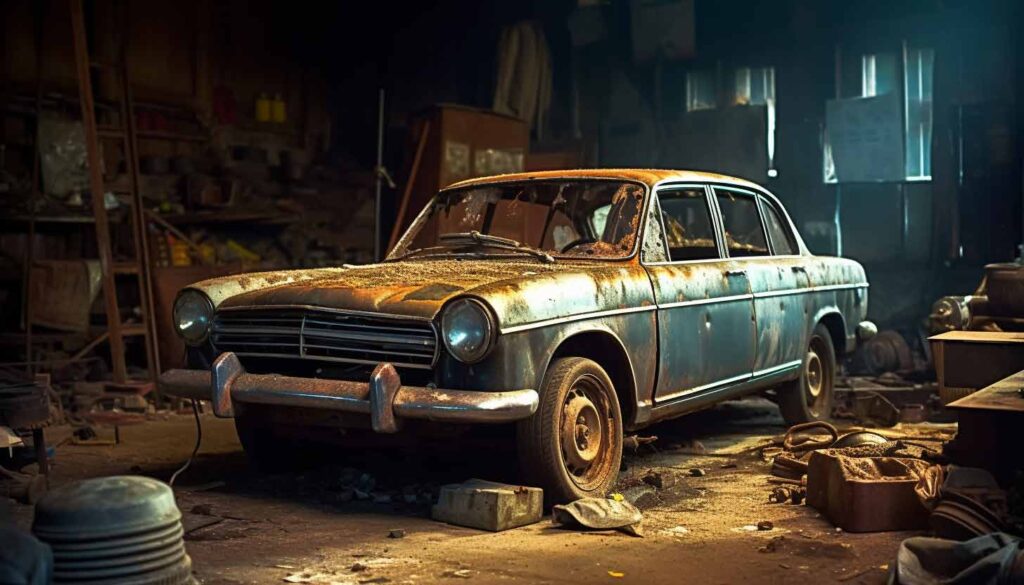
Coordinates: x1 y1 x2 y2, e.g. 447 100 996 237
211 308 437 370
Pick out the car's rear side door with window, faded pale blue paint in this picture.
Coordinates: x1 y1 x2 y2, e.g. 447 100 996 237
715 187 808 377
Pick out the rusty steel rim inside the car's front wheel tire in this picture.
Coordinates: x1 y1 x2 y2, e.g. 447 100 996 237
558 374 614 491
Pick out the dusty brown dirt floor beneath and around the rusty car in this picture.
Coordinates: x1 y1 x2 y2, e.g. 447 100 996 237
8 401 951 584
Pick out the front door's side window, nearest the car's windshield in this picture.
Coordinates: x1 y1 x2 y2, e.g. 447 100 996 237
658 187 719 262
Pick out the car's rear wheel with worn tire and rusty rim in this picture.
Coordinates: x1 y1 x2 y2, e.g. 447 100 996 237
776 323 837 425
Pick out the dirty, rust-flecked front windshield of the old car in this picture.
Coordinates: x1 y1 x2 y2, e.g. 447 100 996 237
388 180 644 259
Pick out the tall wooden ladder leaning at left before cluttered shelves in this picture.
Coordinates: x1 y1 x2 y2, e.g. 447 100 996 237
70 0 160 384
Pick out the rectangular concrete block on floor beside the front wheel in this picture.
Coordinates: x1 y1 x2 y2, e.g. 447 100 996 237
431 479 544 532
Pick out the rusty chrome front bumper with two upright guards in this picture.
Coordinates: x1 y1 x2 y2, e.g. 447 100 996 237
160 352 540 432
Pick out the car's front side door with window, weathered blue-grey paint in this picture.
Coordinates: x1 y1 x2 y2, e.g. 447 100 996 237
644 184 755 403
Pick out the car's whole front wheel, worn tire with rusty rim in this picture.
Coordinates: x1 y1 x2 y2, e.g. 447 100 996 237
516 358 623 505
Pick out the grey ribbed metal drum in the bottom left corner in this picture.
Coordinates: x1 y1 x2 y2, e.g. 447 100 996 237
32 475 195 585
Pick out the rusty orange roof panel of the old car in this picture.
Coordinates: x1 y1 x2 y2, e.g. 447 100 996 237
444 169 764 191
